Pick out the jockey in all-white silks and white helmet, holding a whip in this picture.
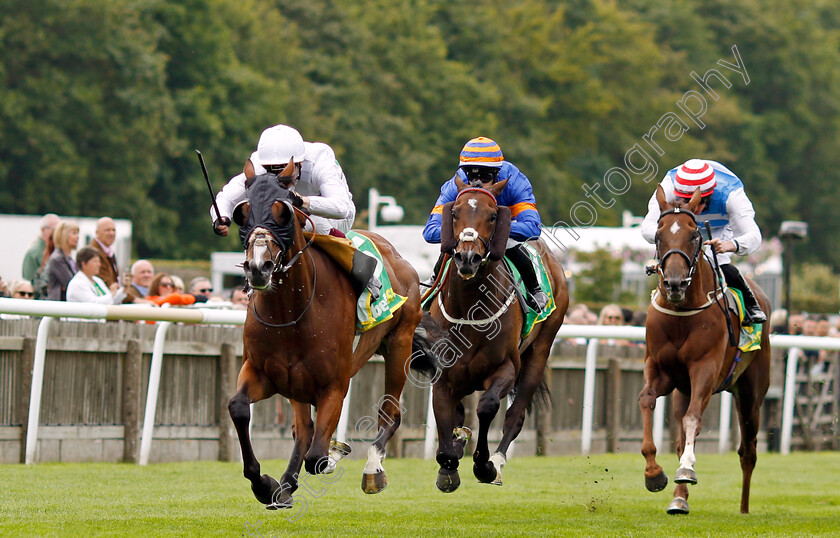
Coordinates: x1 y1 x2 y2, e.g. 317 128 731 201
210 125 382 301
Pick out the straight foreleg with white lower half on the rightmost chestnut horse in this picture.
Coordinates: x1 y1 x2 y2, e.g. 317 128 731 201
674 354 719 484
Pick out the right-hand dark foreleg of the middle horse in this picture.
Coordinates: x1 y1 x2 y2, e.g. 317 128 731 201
473 360 516 485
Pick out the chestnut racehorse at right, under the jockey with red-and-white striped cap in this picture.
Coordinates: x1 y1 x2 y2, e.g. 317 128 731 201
639 187 770 514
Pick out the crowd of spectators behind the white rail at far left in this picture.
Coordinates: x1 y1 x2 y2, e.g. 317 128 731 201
0 209 243 309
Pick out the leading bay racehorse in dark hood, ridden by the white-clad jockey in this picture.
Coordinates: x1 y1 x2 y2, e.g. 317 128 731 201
228 163 430 509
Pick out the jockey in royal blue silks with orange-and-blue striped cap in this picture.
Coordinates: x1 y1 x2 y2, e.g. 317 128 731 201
423 136 549 311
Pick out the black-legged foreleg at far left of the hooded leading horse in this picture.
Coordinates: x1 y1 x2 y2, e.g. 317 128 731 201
228 360 280 505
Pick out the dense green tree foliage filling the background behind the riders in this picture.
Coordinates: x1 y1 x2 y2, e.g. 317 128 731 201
0 0 840 269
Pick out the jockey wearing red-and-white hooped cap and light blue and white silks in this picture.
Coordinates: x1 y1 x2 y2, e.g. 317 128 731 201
642 155 767 325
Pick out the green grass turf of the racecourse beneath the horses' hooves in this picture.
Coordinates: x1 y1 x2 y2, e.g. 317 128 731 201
0 452 840 538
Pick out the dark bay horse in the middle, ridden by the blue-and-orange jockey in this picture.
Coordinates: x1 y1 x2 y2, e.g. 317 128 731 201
423 176 569 493
